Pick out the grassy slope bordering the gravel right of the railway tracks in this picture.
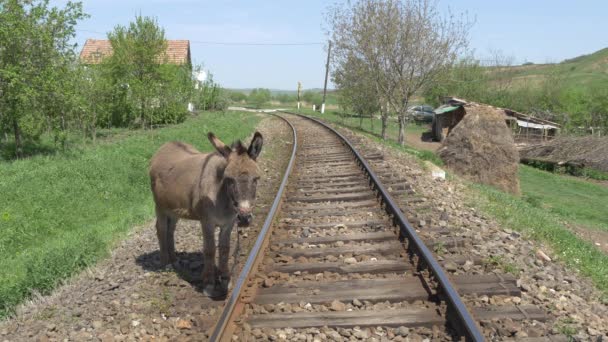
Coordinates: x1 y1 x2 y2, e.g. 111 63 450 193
307 113 608 300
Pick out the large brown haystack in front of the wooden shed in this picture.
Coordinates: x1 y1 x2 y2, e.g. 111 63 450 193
439 104 519 194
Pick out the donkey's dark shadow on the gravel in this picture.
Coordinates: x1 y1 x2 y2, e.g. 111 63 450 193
135 250 224 300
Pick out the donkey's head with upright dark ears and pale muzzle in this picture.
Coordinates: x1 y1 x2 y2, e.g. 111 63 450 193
208 132 264 226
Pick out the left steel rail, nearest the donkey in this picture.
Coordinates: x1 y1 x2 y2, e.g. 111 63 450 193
209 113 298 341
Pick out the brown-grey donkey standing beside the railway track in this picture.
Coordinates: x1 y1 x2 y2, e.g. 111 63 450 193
150 132 263 297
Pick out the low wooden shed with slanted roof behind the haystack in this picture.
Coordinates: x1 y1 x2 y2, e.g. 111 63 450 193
432 97 561 143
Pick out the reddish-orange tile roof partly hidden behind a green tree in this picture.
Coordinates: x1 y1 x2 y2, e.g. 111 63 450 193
80 39 192 65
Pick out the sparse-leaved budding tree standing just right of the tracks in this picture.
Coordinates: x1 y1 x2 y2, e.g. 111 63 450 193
327 0 470 144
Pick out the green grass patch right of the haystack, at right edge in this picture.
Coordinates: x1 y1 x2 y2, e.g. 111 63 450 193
519 165 608 231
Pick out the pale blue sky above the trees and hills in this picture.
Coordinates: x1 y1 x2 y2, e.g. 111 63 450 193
51 0 608 90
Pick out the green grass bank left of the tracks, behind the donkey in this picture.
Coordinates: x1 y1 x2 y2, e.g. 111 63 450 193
0 112 259 317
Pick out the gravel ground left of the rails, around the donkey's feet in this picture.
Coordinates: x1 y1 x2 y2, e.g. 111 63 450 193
0 116 292 341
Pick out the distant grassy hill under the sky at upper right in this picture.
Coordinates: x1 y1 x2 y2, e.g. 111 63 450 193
496 48 608 88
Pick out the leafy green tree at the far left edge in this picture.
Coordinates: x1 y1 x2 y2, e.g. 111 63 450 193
0 0 86 157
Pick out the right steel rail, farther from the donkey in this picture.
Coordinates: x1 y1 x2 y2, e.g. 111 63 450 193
292 112 485 341
